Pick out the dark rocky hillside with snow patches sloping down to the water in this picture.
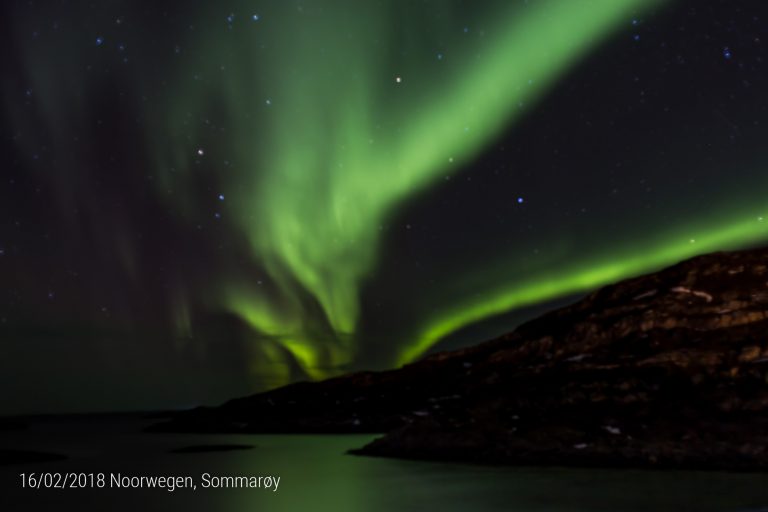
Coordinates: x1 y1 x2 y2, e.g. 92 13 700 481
156 249 768 469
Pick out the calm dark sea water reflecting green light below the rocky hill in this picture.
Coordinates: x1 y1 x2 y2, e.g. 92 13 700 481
0 418 768 512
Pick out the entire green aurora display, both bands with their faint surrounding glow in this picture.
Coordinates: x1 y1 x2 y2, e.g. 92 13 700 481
10 0 768 388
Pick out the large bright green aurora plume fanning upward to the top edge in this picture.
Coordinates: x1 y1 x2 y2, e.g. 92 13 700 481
172 0 660 371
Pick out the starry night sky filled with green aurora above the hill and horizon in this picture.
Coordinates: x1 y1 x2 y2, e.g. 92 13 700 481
0 0 768 413
